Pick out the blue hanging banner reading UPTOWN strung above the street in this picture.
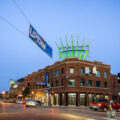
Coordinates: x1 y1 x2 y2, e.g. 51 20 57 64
29 25 52 58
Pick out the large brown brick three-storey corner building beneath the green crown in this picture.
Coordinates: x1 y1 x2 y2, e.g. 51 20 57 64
24 58 111 106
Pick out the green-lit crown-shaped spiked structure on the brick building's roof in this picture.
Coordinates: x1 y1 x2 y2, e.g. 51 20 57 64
55 33 91 60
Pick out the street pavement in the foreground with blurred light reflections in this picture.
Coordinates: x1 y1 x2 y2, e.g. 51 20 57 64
0 103 120 120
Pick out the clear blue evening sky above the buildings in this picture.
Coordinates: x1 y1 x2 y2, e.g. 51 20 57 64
0 0 120 92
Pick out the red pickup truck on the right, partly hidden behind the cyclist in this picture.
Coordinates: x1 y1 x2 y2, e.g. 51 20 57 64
89 99 120 112
